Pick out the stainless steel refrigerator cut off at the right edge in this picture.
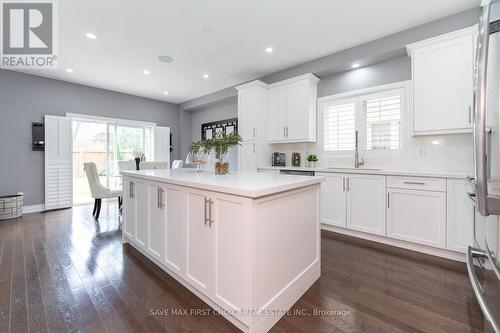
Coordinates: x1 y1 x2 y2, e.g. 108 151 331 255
467 1 500 333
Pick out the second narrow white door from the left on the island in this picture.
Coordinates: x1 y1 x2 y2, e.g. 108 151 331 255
134 181 149 250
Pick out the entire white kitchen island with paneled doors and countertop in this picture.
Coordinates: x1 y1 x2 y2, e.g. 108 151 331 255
122 169 323 332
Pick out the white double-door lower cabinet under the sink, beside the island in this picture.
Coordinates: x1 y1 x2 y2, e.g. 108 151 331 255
317 173 385 236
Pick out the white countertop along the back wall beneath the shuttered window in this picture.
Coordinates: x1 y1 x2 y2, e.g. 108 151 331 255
258 166 467 179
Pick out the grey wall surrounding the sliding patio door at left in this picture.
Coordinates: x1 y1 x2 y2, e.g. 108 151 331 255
0 70 179 205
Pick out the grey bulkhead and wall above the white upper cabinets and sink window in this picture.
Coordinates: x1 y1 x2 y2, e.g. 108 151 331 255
179 8 479 158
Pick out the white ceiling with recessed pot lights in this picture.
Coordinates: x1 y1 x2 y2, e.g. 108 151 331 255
13 0 479 103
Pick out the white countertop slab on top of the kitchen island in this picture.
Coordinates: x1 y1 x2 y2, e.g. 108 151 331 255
121 168 324 198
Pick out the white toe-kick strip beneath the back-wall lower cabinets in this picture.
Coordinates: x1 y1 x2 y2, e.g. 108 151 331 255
321 223 465 262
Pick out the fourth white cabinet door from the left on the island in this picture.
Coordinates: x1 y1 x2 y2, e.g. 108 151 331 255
164 186 186 275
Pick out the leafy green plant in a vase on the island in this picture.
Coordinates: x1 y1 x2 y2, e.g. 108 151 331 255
189 132 242 175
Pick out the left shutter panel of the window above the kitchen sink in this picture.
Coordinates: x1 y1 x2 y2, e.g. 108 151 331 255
323 100 356 152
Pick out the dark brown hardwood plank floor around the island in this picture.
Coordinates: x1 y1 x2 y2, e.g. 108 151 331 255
0 204 483 333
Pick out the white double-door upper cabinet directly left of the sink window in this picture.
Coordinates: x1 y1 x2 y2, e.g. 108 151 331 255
268 74 319 143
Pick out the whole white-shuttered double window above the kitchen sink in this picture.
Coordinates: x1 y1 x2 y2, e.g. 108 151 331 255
319 83 406 156
